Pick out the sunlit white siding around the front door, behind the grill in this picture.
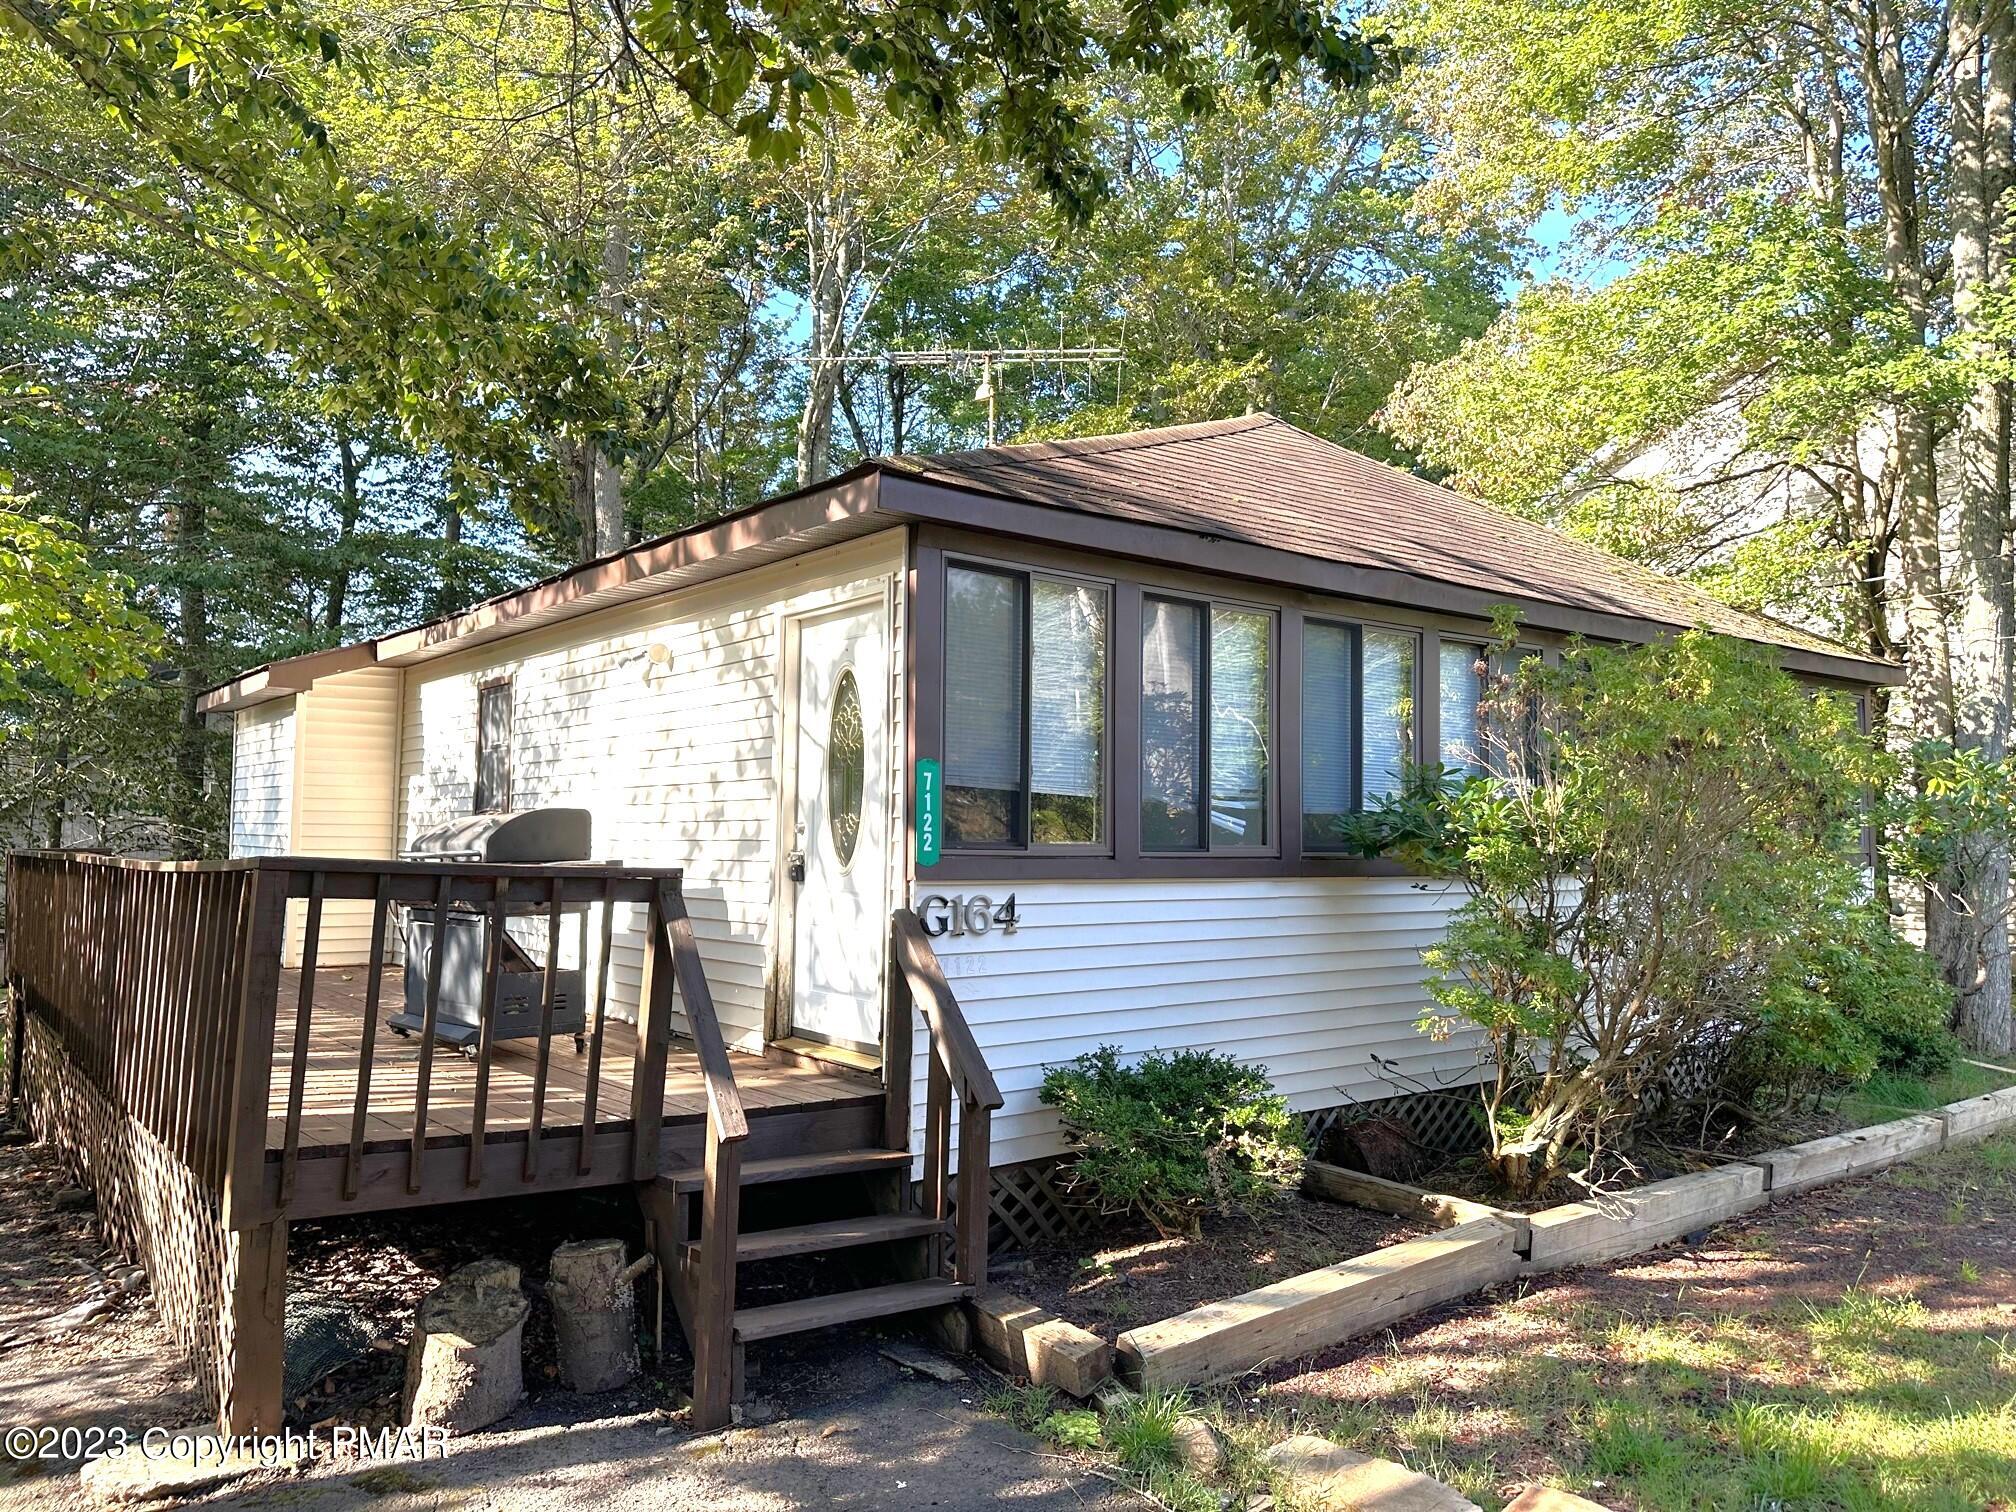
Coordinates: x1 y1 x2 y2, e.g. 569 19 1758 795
399 530 905 1048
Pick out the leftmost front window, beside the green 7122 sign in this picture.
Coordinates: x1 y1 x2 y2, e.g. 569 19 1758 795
946 562 1109 851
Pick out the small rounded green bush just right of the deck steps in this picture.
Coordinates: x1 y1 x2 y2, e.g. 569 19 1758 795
1042 1044 1306 1234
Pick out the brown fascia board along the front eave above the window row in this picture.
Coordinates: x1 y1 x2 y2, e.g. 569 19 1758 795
875 468 1903 687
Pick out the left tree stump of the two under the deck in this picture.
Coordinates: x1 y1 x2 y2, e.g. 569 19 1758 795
403 1260 532 1433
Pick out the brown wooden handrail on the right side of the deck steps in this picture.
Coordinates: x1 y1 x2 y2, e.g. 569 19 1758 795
885 909 1002 1296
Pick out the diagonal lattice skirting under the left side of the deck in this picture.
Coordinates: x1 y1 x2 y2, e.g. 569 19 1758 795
20 1016 243 1407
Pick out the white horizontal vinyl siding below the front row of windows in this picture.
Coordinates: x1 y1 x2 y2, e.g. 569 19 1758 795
911 877 1476 1165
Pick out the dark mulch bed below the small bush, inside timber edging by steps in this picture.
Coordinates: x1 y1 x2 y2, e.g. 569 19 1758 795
1008 1195 1433 1339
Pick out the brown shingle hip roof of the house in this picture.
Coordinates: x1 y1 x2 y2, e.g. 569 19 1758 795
891 415 1883 665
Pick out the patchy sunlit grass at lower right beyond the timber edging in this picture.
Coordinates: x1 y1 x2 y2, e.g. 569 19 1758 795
1224 1145 2016 1512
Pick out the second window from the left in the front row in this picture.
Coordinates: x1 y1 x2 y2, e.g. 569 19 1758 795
1141 597 1274 851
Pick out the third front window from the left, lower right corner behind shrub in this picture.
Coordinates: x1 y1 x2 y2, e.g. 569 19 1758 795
1302 619 1421 851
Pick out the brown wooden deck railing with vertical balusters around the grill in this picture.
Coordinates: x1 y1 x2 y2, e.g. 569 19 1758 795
8 853 693 1226
